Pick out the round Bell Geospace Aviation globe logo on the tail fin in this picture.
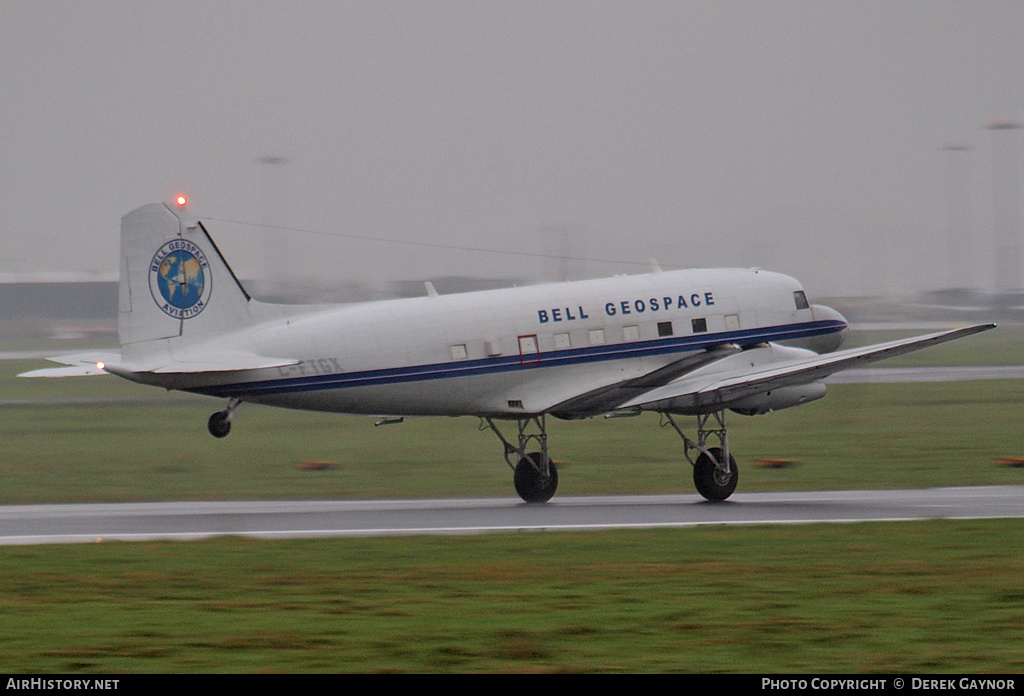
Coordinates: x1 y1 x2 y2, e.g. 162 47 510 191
150 240 213 319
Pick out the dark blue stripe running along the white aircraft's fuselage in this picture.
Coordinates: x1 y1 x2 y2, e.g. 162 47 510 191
184 320 847 397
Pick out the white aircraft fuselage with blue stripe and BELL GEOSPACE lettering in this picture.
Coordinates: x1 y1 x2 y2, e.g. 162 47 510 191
129 269 846 418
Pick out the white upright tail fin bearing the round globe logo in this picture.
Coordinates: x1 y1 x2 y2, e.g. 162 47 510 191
118 203 250 345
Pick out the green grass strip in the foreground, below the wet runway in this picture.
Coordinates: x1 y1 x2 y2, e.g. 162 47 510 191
0 520 1024 673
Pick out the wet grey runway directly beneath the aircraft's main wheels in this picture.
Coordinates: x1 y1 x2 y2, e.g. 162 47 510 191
0 486 1024 545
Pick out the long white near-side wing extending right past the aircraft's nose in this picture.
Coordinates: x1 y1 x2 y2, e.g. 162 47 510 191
616 323 995 412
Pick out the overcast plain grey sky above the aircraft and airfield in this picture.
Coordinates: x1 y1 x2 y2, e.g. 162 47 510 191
0 0 1024 295
